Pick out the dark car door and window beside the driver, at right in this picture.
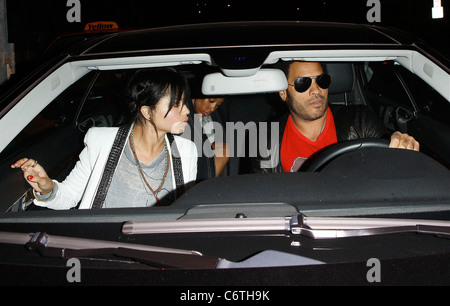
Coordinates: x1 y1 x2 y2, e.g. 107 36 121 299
359 61 450 168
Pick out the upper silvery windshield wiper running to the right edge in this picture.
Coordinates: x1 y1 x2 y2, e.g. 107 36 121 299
122 214 450 239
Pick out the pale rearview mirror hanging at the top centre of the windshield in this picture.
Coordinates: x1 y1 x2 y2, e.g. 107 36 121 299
202 69 288 96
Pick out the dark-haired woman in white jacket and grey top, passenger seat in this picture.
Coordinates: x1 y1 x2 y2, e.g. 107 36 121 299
11 70 197 209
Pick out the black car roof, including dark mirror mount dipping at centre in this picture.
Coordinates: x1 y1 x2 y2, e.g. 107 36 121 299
44 21 450 72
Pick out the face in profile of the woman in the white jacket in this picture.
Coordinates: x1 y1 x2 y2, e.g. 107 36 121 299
144 95 189 134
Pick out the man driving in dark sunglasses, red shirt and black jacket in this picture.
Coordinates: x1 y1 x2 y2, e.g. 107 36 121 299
256 62 419 172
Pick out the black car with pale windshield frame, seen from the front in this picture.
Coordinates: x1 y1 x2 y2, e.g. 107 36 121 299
0 21 450 286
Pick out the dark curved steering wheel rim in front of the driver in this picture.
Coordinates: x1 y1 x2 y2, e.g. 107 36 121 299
300 138 389 172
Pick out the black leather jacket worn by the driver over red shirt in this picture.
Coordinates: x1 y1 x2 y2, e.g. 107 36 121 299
252 105 390 173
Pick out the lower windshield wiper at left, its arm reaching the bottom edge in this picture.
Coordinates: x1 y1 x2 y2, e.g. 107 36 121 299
0 232 324 269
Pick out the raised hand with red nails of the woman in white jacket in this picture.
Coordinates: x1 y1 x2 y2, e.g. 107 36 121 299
11 158 55 195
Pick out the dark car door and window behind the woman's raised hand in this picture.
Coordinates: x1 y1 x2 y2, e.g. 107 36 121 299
0 71 128 211
